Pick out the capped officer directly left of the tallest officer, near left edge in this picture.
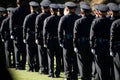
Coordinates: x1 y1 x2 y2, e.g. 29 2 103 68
0 8 15 68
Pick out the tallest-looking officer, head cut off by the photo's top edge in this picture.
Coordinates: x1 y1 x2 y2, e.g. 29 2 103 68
10 0 29 70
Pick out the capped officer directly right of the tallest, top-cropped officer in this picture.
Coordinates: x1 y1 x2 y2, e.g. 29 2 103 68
23 1 39 72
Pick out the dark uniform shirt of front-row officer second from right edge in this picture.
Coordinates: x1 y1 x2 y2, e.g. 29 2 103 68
90 16 111 48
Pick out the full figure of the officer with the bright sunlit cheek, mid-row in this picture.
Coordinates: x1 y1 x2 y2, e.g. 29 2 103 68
58 2 79 80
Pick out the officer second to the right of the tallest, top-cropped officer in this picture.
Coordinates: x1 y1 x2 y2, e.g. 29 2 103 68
35 2 50 74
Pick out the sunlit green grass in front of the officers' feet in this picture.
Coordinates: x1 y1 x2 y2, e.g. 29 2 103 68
9 68 64 80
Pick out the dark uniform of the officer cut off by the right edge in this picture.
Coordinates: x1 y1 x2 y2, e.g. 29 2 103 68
110 19 120 80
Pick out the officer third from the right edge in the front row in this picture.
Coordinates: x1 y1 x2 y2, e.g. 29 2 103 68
73 4 94 80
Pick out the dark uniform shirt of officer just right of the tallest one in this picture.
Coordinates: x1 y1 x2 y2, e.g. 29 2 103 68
23 11 38 42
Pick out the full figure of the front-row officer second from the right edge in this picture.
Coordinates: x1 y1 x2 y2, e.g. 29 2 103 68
90 4 111 80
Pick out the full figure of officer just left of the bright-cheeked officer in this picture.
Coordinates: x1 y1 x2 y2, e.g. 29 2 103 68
43 4 62 77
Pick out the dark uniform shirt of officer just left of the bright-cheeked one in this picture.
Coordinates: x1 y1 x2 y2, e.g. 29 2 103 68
43 14 60 44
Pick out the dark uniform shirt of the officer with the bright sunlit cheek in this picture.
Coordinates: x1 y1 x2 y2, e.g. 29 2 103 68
58 13 79 47
